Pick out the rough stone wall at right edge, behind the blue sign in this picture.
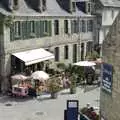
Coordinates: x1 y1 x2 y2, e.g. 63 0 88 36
100 10 120 120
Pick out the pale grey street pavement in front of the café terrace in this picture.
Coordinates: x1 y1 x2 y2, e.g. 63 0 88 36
0 86 100 120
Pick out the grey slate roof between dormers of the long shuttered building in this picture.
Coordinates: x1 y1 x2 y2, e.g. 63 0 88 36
0 0 91 17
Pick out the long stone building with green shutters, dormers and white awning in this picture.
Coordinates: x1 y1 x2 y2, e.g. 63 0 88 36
0 0 95 91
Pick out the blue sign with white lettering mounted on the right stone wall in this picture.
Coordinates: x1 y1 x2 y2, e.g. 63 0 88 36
102 63 113 93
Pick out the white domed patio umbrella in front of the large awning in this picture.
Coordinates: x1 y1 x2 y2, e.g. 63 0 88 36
31 71 49 81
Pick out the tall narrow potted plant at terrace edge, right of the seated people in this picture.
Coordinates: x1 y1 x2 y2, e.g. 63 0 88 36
70 74 76 94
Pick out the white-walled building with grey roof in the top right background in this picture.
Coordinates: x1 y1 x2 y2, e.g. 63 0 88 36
94 0 120 56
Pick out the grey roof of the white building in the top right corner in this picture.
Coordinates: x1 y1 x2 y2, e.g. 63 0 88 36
100 0 120 7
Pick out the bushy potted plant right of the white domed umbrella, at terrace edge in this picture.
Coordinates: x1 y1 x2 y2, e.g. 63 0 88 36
47 77 61 99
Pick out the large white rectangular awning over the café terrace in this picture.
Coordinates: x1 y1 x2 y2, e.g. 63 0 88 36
12 48 54 66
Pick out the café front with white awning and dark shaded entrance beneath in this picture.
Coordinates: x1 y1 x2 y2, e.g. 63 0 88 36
11 48 54 74
